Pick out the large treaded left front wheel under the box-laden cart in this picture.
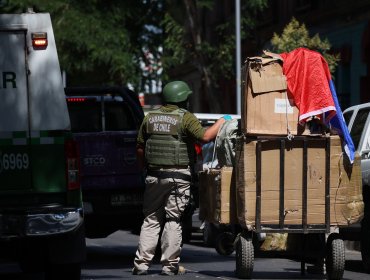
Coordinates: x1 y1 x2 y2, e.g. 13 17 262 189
236 235 254 279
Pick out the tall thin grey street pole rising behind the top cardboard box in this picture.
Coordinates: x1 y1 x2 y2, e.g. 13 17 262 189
235 0 241 115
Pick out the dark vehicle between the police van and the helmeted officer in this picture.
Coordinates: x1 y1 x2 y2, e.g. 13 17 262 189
65 87 144 238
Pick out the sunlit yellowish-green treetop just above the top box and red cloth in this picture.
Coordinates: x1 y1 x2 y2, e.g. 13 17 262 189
271 18 340 73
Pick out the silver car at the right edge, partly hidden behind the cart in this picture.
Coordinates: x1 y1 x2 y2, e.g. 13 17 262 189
341 103 370 272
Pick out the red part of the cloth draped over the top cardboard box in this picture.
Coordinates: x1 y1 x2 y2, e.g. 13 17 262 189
281 48 336 122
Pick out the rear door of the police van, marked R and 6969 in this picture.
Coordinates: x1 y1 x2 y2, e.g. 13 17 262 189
0 28 31 191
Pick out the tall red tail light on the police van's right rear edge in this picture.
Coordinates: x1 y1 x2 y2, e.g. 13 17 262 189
64 140 80 190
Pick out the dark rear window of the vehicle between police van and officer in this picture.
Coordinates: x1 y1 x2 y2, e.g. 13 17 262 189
68 98 137 132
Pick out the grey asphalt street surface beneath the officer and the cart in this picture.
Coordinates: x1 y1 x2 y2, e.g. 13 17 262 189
82 232 370 280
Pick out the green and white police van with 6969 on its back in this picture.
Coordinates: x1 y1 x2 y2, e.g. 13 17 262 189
0 10 85 279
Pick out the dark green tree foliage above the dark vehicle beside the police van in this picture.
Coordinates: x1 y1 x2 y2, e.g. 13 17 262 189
3 0 162 89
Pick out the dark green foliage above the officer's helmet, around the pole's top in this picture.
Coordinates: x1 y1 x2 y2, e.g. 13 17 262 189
162 0 268 81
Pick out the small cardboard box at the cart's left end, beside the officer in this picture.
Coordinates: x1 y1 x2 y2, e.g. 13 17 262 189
199 166 237 224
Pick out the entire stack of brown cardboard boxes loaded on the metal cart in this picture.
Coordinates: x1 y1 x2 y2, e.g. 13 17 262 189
199 53 363 232
